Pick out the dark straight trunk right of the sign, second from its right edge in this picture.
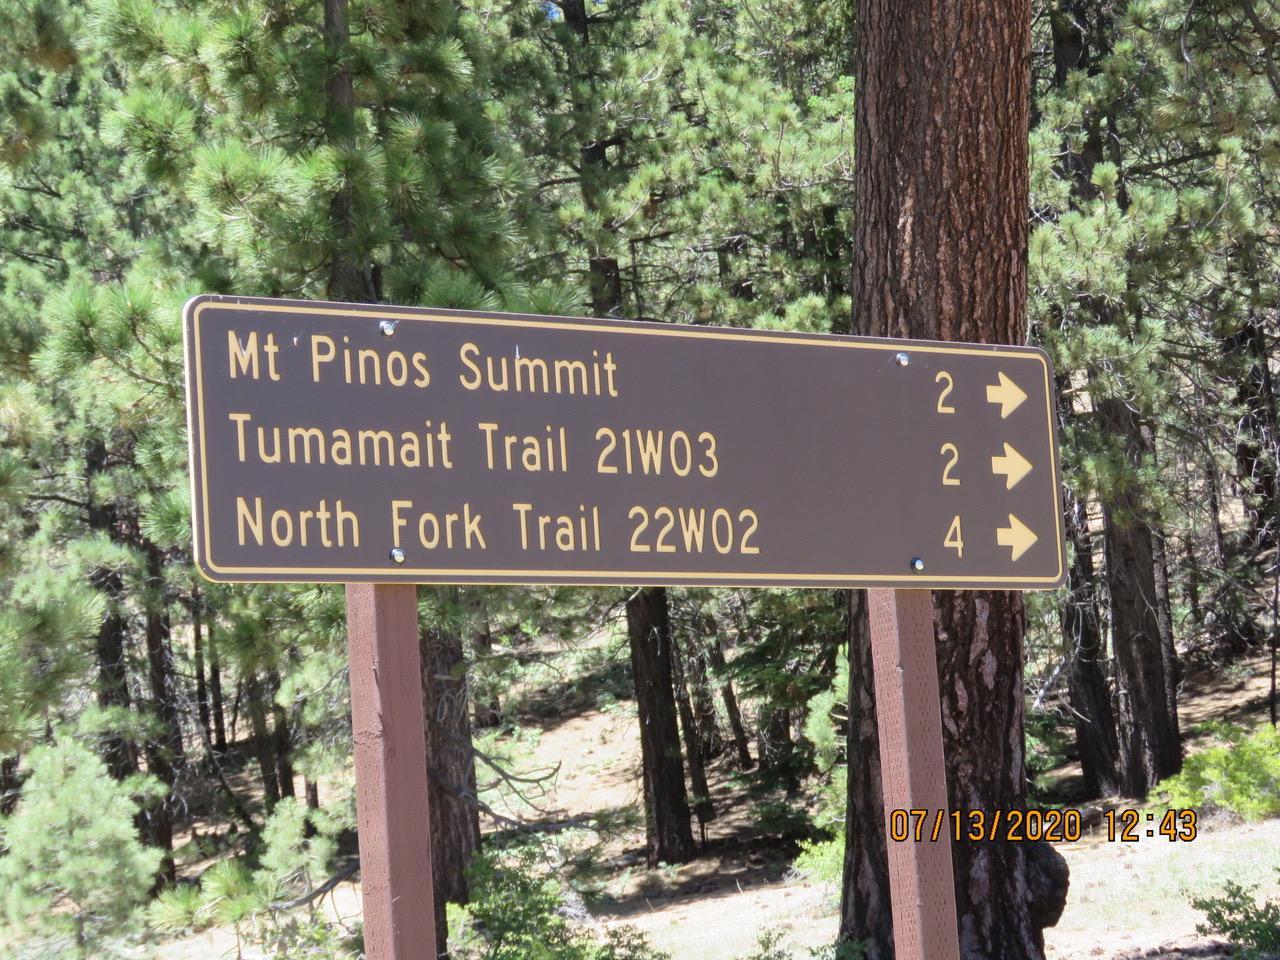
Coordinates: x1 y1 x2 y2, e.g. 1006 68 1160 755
1097 398 1183 797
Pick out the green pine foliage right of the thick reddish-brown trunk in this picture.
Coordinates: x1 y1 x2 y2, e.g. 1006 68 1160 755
1029 0 1280 643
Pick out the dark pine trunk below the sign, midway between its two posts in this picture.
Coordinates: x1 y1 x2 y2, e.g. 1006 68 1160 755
627 586 695 867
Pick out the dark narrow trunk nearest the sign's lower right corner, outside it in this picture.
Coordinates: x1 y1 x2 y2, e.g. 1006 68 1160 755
1061 493 1120 797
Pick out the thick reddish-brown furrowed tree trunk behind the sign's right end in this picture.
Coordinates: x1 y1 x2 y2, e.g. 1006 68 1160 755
841 0 1066 960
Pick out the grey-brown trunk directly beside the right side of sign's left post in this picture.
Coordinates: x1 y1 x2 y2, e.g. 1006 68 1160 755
419 588 480 956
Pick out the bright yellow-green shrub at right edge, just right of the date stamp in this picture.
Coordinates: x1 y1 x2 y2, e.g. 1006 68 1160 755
1156 723 1280 820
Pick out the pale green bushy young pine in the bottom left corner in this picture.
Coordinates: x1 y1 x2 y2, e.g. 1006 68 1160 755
0 740 160 956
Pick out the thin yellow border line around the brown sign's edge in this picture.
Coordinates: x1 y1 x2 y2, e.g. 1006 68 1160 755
182 294 1064 589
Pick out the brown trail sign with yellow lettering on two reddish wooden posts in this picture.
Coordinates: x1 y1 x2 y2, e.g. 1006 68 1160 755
177 297 1065 960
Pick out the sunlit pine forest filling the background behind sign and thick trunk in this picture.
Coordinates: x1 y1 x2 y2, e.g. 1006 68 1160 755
0 0 1280 960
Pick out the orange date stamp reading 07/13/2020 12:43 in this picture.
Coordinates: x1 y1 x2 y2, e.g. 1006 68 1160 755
888 806 1198 844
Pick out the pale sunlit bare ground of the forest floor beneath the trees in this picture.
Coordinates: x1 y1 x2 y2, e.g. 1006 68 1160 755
159 655 1280 960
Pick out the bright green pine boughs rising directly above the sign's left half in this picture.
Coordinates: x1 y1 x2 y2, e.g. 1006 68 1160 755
95 0 547 307
